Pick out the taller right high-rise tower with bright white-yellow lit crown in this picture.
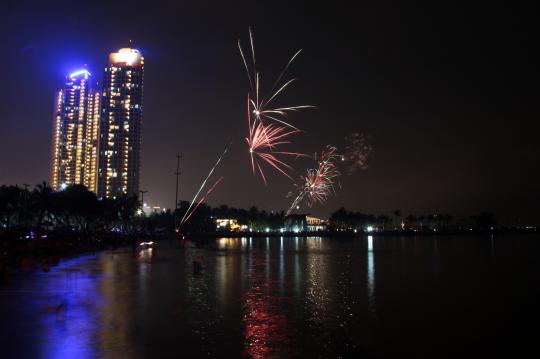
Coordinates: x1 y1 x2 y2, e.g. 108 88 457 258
97 48 144 198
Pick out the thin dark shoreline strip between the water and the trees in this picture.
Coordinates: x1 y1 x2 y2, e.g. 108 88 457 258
0 228 538 284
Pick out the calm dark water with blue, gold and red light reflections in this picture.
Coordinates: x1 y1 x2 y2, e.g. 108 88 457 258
0 236 540 358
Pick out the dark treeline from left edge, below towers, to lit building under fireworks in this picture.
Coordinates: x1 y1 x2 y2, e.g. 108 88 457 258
0 182 292 236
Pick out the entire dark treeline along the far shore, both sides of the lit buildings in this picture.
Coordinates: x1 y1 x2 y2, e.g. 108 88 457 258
0 182 510 235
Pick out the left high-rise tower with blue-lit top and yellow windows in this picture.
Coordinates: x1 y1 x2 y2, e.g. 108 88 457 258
51 70 100 192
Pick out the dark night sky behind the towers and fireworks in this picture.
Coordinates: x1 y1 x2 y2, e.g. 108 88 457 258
0 0 540 223
